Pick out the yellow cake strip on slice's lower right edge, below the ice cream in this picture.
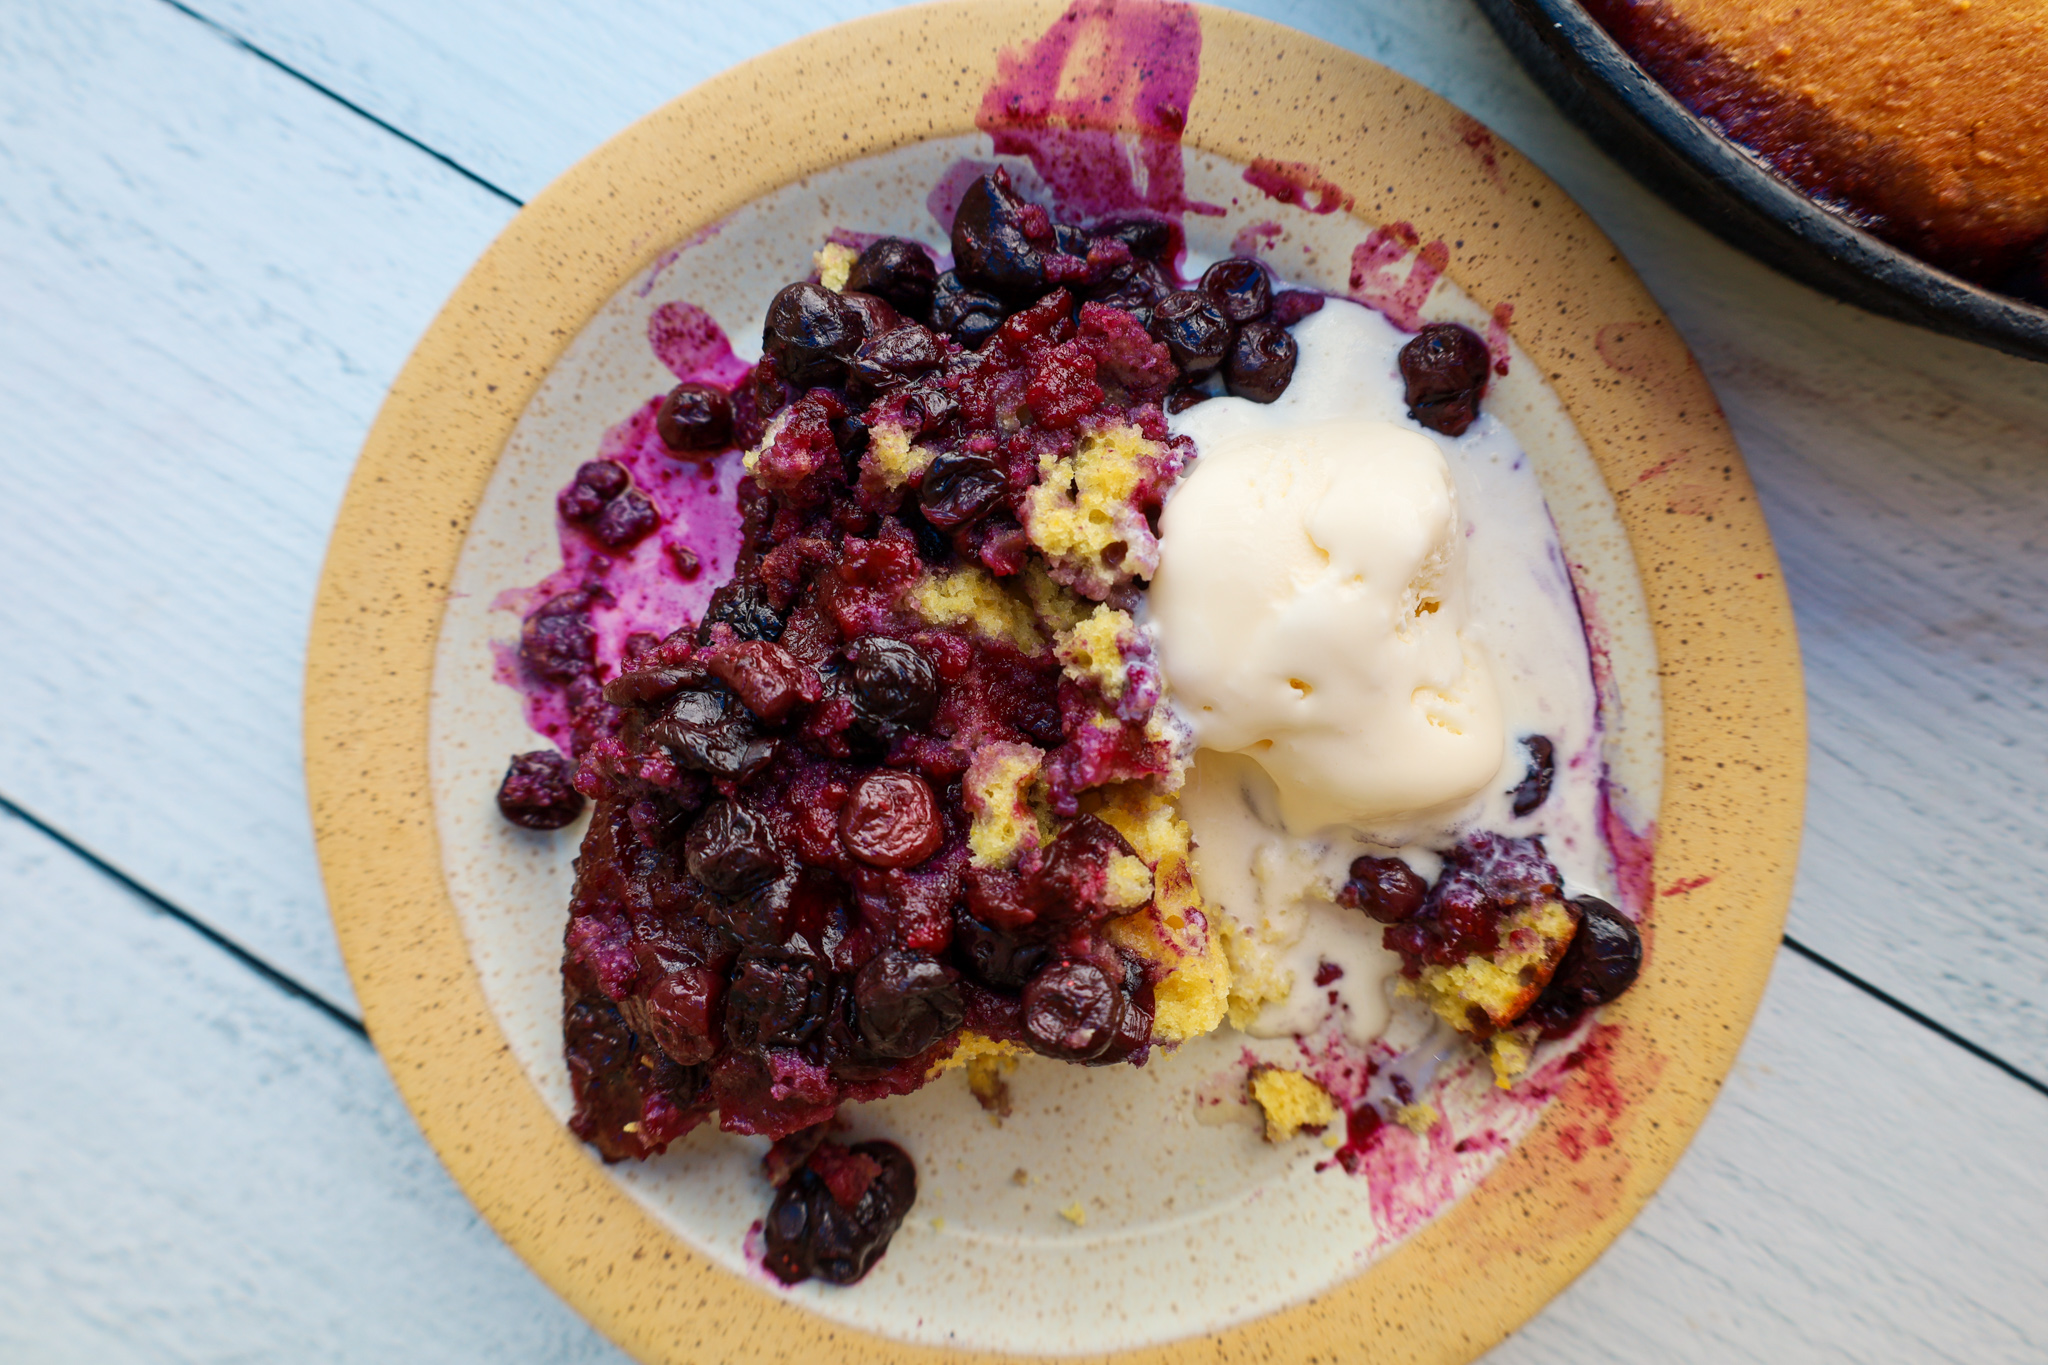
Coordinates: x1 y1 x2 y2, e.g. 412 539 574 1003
1094 782 1231 1042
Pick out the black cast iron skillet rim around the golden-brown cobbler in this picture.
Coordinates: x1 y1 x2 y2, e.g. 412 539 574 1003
1479 0 2048 360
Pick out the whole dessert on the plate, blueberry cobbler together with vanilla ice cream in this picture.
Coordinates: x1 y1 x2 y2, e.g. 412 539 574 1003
500 170 1640 1283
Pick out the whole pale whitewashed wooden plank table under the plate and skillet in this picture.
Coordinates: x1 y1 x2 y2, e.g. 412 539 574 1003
0 0 2048 1365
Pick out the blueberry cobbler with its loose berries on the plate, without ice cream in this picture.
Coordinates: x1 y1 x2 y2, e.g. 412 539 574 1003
500 170 1634 1283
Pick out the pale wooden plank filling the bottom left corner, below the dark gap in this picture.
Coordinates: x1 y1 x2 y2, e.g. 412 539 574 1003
0 817 625 1365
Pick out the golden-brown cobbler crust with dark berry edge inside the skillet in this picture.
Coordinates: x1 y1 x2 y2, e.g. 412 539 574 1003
1585 0 2048 303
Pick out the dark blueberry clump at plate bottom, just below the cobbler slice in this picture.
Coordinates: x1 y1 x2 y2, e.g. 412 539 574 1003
762 1142 918 1285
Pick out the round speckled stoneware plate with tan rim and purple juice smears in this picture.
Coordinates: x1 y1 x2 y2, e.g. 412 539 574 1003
307 0 1804 1361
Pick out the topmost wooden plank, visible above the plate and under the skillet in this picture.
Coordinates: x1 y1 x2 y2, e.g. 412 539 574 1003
167 0 2048 1074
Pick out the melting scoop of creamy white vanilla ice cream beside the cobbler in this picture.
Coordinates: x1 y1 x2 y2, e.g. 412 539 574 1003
1149 417 1503 833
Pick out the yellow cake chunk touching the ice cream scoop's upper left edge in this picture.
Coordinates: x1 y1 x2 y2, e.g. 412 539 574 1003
1024 426 1159 596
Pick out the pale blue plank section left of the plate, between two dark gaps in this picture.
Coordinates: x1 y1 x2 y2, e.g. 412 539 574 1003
0 0 510 1001
